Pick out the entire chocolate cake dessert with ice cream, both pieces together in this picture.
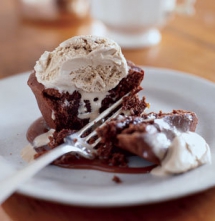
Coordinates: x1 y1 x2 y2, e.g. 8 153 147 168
27 35 210 174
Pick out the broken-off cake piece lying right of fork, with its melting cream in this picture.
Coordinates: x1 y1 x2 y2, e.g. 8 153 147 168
97 110 211 175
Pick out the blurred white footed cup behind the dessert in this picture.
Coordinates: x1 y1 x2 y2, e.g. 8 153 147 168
91 0 194 48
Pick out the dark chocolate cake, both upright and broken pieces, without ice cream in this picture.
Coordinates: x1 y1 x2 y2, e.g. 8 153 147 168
28 62 198 172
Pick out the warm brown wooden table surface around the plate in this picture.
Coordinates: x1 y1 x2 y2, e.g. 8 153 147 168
0 0 215 221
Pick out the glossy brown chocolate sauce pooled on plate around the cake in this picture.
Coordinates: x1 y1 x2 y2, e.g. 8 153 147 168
26 117 156 173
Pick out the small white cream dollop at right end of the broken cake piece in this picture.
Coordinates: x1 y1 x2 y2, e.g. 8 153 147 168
151 131 211 176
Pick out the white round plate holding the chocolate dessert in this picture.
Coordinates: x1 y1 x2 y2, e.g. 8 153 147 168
0 67 215 207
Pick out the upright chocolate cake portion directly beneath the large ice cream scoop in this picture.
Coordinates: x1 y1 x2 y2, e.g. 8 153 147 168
28 61 144 131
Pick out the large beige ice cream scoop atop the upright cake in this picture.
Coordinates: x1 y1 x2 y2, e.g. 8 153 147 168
34 35 128 93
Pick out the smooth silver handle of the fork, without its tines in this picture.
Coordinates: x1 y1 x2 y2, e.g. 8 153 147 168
0 144 72 204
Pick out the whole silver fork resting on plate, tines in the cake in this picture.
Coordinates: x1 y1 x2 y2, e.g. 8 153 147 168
0 95 127 204
